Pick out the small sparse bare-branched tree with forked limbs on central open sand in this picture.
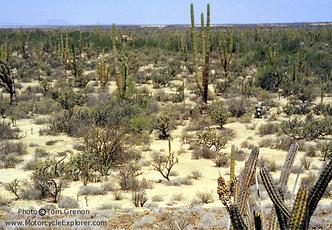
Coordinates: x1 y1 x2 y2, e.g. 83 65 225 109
151 152 179 181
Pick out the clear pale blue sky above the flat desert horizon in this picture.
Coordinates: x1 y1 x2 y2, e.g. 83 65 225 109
0 0 332 25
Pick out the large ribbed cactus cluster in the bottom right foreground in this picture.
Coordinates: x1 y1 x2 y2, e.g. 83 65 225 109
217 144 332 230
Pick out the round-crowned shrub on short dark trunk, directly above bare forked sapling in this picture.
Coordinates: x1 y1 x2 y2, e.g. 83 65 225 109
153 111 175 139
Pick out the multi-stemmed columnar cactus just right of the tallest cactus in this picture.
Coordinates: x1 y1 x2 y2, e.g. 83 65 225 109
218 30 234 78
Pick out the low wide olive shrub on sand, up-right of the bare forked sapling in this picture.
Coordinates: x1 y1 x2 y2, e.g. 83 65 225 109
194 129 229 153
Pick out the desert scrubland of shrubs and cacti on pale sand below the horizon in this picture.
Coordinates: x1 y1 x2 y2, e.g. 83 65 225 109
0 2 332 229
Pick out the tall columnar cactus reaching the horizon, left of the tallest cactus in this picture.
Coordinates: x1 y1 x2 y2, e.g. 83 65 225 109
112 25 129 98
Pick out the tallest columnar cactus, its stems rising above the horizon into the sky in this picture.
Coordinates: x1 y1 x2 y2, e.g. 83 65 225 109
190 4 211 103
